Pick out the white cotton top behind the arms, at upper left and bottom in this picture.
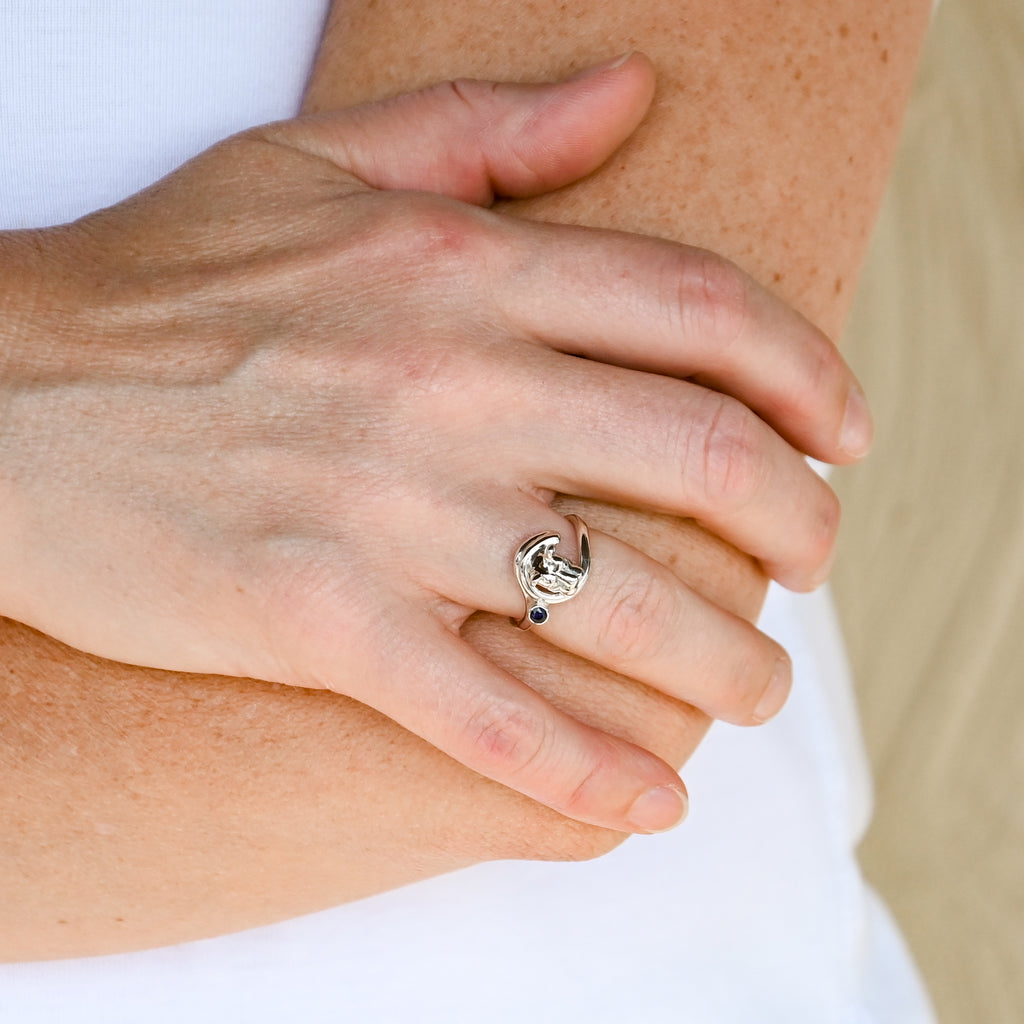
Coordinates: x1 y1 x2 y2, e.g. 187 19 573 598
0 0 933 1024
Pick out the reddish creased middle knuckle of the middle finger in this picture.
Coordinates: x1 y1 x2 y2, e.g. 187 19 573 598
683 391 765 509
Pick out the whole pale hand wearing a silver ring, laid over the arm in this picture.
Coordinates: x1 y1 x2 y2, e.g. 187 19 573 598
0 60 867 830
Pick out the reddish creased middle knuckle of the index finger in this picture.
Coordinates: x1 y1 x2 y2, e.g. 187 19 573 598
677 249 751 356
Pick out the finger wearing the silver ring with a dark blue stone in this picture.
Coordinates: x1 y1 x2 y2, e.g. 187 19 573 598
432 503 792 725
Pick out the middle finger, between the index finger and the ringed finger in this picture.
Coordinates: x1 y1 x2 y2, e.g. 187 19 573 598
492 351 840 590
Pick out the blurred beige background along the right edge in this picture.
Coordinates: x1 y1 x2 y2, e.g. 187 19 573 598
836 0 1024 1024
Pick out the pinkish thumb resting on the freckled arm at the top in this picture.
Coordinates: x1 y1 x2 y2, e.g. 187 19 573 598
283 54 654 205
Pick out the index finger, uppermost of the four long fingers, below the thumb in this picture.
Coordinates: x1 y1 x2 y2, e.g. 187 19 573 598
494 222 872 463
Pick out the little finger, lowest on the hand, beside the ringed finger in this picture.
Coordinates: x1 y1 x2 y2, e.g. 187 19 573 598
354 612 686 833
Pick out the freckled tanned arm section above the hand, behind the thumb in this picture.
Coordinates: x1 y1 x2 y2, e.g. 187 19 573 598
306 0 931 337
